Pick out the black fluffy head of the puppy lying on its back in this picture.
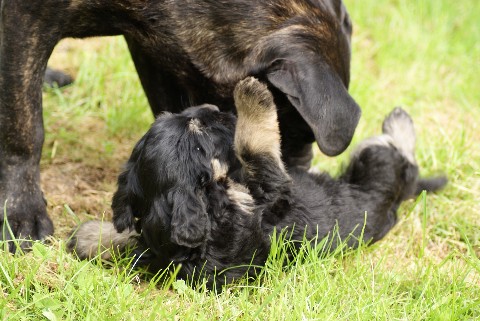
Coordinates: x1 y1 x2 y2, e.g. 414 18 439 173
112 105 235 249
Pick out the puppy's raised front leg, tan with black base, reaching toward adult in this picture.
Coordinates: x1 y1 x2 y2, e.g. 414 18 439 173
234 77 291 198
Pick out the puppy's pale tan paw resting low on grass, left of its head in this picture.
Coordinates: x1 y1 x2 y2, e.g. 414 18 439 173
67 221 138 260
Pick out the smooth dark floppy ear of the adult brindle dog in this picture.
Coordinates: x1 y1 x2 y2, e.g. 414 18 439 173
266 59 361 156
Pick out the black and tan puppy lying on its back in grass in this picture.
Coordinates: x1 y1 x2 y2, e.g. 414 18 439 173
69 78 445 286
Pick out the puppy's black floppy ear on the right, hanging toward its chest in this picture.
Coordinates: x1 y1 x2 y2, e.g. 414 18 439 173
170 186 208 248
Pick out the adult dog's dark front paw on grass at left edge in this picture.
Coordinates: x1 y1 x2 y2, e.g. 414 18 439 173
0 192 53 252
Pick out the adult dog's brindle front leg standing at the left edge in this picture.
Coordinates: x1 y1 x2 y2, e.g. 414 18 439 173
0 1 58 250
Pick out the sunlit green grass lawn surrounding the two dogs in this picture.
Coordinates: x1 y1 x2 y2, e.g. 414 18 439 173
0 0 480 320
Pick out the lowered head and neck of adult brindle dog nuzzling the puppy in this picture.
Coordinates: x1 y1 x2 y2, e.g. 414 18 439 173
175 0 360 156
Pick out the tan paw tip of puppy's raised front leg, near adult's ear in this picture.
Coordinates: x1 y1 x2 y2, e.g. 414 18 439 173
233 77 277 119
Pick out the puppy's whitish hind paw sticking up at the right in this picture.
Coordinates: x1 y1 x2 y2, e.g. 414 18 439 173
382 107 416 164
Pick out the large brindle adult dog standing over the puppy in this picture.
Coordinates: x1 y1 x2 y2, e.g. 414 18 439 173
0 0 360 250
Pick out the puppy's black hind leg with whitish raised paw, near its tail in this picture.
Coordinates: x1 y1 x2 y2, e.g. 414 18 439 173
340 108 446 241
